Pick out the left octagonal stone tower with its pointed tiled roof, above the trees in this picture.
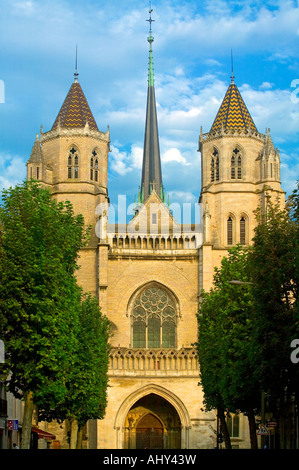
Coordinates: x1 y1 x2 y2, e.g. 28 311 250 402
27 70 110 294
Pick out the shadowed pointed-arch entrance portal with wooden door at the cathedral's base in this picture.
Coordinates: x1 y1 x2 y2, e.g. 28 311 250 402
125 393 181 449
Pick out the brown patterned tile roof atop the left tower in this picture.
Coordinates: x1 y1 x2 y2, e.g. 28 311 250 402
52 81 98 130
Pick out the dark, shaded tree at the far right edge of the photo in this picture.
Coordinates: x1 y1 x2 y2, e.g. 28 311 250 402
249 194 299 446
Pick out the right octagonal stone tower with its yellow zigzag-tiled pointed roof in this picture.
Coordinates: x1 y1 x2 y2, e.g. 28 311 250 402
199 75 284 289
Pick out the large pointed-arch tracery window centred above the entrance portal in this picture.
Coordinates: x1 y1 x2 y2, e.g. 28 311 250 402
132 286 177 348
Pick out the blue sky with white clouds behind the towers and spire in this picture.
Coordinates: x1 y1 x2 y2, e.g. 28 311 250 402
0 0 299 217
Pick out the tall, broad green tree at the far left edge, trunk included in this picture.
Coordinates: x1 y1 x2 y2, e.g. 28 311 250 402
0 182 87 448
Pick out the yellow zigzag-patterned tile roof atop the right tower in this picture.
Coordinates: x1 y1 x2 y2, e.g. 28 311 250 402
210 81 257 132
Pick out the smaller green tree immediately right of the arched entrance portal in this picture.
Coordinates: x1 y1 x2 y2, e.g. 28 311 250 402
198 246 260 448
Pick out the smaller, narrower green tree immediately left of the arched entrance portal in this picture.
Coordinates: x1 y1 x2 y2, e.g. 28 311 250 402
39 294 110 449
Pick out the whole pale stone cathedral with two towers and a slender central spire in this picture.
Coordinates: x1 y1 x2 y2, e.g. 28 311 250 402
27 19 285 449
